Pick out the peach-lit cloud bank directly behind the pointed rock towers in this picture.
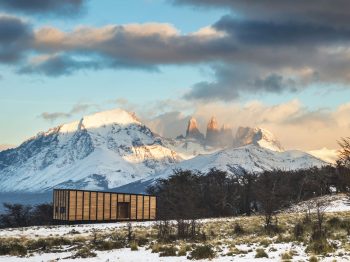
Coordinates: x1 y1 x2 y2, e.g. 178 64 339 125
144 100 350 151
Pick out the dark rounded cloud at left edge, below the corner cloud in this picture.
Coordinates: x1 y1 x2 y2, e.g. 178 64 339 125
0 15 33 63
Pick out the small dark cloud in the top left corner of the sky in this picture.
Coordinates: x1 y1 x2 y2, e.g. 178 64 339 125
0 0 86 17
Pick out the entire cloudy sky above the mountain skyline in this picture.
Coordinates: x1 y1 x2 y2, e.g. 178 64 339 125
0 0 350 150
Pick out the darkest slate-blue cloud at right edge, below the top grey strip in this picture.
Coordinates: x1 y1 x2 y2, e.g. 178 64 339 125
214 16 350 46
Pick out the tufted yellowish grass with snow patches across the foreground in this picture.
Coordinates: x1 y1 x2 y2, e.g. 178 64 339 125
0 212 350 261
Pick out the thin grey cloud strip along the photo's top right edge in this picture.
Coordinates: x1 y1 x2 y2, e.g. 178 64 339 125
169 0 350 27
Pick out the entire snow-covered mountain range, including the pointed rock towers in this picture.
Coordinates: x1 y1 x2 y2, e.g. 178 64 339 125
0 109 327 193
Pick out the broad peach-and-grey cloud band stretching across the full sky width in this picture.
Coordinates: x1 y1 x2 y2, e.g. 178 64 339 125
0 12 350 101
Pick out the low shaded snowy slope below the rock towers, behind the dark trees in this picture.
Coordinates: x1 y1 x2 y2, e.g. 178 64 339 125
122 145 327 190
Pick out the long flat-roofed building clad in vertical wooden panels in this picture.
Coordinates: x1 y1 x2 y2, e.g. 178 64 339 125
53 189 157 222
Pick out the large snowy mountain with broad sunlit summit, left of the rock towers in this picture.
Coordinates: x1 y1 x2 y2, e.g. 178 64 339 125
0 109 181 192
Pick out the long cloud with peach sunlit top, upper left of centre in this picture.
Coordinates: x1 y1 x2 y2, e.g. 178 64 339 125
30 23 230 66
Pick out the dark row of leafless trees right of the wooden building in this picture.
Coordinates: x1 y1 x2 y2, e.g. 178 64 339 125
148 165 350 224
